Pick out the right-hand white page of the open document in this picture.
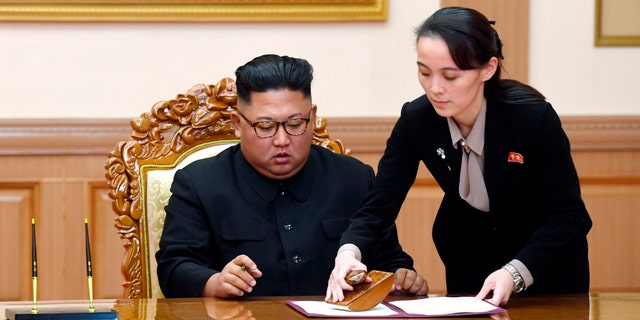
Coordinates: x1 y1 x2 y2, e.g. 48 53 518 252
390 297 496 316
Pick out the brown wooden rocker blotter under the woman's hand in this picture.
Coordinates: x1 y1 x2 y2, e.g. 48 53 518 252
330 270 393 311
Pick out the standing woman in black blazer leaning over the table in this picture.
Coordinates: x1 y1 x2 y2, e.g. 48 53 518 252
326 7 591 304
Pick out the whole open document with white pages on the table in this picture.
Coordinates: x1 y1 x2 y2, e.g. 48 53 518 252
286 297 506 318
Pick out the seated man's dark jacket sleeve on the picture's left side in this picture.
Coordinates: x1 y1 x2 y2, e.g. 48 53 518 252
156 170 217 298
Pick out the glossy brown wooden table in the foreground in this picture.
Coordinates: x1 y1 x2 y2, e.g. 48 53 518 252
0 292 640 320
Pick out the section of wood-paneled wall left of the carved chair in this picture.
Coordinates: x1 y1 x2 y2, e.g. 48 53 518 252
0 120 130 300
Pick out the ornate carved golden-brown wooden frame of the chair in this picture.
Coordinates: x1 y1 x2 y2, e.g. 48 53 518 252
105 78 350 299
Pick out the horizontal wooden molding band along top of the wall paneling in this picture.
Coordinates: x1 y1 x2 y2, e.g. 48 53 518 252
0 116 640 155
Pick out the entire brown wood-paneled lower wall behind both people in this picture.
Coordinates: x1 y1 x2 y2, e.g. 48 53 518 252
0 116 640 300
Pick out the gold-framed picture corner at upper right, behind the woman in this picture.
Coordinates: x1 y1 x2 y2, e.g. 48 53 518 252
594 0 640 47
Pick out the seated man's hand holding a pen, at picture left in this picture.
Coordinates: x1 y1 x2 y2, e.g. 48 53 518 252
202 254 262 298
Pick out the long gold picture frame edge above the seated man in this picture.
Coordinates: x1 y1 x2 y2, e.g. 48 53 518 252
0 0 389 22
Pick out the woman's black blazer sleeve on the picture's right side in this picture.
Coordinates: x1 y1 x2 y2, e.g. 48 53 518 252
515 105 592 283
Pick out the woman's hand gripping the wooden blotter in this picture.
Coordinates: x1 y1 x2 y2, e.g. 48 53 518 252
324 250 371 302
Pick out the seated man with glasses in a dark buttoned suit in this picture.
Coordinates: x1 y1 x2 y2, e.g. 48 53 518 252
156 55 428 298
